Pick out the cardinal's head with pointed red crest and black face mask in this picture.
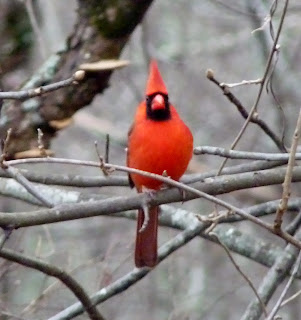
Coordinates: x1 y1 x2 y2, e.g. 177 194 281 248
146 60 171 121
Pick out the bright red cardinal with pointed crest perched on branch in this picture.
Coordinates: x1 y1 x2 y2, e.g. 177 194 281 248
127 60 193 267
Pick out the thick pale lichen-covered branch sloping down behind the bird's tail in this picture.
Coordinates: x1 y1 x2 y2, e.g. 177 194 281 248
0 168 301 278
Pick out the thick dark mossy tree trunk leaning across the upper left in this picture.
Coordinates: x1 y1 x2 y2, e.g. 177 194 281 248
0 0 152 158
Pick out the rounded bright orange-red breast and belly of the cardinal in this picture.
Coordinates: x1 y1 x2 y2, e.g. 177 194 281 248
128 119 193 190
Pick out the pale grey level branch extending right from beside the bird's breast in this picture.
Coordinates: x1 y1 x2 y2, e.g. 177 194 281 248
193 146 301 161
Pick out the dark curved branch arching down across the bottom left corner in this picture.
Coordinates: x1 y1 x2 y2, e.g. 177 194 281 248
0 249 104 320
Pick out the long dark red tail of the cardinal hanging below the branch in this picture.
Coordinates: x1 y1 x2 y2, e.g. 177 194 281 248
135 207 159 268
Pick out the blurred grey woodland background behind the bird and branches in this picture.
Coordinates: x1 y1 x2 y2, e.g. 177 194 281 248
0 0 301 320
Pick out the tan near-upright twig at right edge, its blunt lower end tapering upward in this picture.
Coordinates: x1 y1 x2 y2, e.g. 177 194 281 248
274 108 301 232
